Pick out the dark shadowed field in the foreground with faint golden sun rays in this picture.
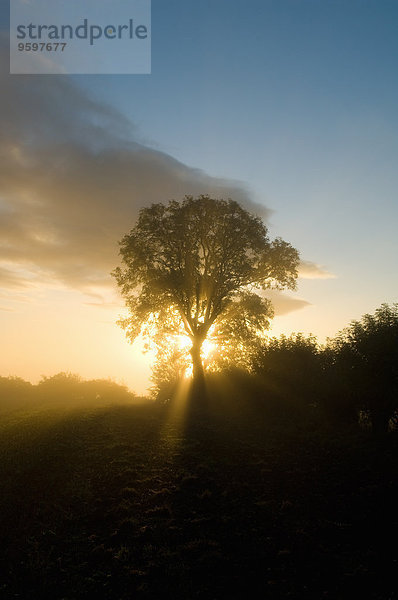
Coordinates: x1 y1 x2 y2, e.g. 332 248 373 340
0 402 398 600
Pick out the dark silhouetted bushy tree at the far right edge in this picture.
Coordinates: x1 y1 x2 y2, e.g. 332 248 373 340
329 304 398 434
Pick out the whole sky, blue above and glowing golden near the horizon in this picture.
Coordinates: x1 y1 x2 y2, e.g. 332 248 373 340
0 0 398 393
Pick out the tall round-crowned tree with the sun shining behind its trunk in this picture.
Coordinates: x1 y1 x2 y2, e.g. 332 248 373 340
113 195 299 380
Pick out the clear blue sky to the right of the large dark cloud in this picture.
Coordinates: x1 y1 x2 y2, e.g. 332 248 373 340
77 0 398 330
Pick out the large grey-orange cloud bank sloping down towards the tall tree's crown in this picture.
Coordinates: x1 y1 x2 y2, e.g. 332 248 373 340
0 40 269 291
